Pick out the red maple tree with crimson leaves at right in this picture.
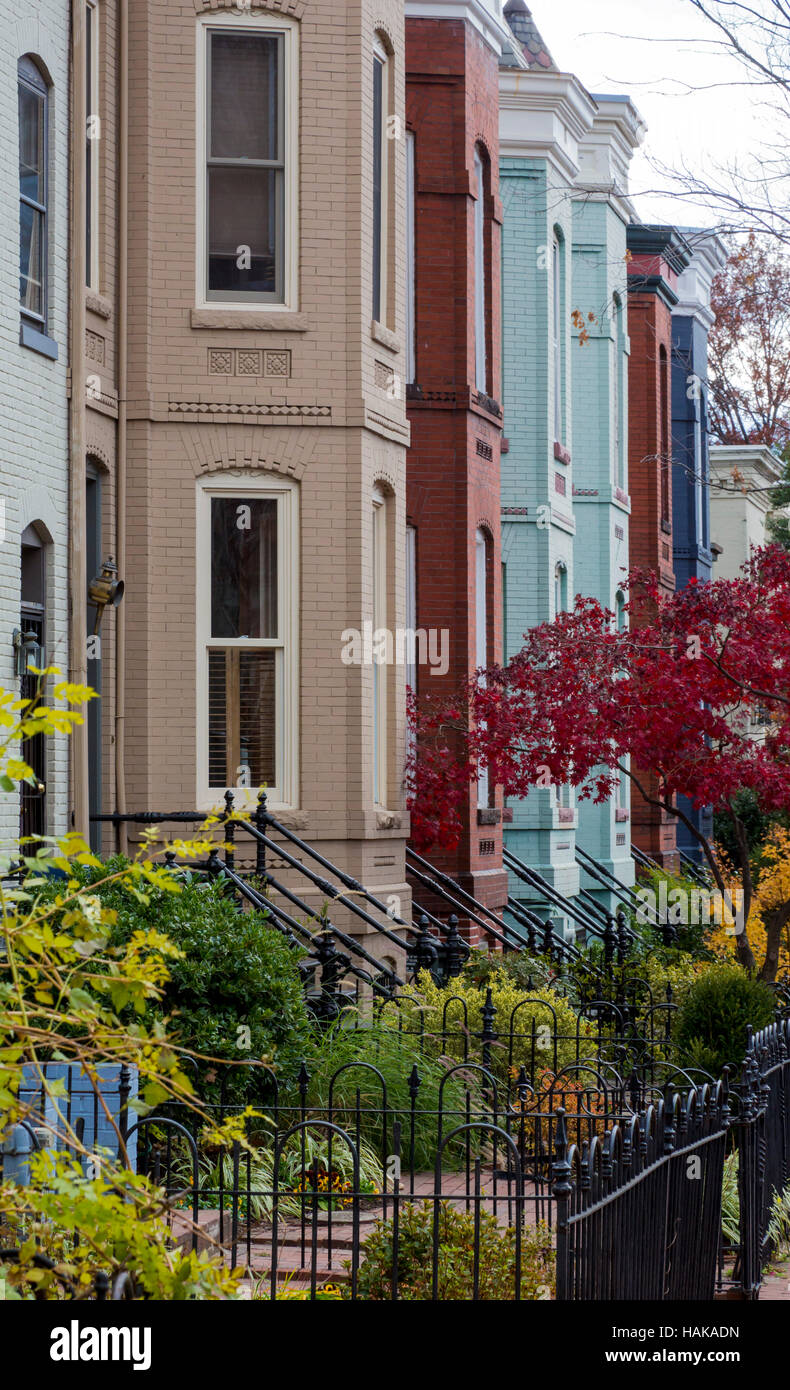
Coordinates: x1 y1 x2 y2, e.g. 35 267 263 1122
408 546 790 979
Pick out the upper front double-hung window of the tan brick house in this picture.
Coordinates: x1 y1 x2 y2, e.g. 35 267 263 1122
198 15 296 306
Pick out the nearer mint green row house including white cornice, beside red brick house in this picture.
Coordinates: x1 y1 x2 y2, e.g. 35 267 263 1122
499 0 595 928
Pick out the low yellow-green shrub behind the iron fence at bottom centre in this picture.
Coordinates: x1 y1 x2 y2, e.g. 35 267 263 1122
344 1202 554 1302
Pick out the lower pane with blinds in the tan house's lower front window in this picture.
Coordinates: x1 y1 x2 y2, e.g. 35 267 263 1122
209 648 277 788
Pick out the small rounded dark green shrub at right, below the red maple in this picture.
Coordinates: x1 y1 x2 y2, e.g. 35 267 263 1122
675 965 775 1077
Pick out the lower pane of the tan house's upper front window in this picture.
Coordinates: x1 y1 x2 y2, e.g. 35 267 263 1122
209 167 282 295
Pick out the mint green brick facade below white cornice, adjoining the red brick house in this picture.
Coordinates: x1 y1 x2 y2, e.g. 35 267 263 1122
499 157 579 919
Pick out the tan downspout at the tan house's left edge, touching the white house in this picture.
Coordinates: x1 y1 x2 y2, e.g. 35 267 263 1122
68 0 90 841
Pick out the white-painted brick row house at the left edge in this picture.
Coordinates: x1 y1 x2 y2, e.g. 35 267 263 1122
0 0 71 848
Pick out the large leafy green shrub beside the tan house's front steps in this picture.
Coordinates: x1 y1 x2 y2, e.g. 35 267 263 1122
33 856 310 1101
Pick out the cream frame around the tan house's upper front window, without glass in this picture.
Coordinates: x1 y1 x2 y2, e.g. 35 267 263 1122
195 10 299 314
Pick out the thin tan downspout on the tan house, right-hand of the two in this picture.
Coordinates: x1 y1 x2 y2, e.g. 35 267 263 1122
115 0 129 853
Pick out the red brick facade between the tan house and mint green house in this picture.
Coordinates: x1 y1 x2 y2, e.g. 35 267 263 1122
406 18 506 908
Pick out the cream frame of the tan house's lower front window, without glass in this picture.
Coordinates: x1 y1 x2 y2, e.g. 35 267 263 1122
195 474 299 810
